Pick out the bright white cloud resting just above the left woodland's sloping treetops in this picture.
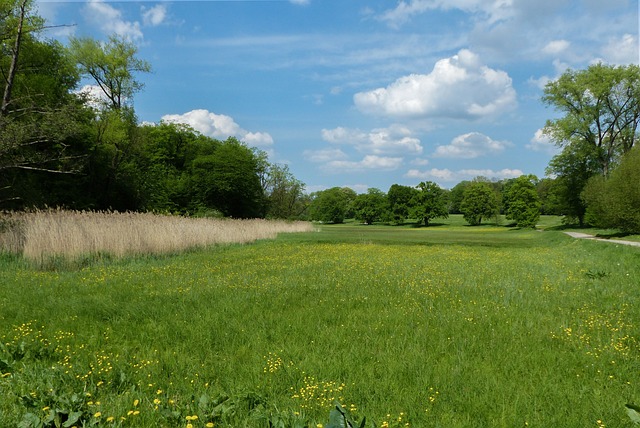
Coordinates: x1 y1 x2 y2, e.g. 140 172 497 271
162 109 273 146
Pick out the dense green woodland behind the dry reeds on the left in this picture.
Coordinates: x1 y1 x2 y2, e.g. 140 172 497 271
0 0 304 218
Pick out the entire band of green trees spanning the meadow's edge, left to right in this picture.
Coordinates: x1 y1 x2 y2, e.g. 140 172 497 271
0 0 640 232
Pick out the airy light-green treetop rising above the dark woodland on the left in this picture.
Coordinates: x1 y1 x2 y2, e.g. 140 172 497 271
69 35 151 109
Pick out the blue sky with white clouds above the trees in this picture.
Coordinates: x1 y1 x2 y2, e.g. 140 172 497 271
37 0 640 193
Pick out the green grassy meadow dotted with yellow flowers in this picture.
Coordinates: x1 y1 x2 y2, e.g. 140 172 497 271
0 216 640 428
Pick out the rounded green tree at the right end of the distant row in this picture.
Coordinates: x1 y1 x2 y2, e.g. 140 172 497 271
503 175 541 227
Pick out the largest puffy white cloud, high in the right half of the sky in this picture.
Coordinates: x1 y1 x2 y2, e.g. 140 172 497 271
354 49 516 119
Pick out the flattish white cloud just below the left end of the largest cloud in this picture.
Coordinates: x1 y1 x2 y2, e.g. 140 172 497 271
322 125 422 155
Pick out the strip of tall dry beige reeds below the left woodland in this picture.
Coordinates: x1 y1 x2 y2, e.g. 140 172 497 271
0 210 312 263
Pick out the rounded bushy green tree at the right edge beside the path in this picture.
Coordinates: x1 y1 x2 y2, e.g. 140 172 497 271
583 148 640 233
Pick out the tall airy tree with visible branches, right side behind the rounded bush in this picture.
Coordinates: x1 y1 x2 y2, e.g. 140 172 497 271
542 64 640 225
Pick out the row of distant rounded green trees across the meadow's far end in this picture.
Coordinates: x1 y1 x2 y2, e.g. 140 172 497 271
309 176 544 227
